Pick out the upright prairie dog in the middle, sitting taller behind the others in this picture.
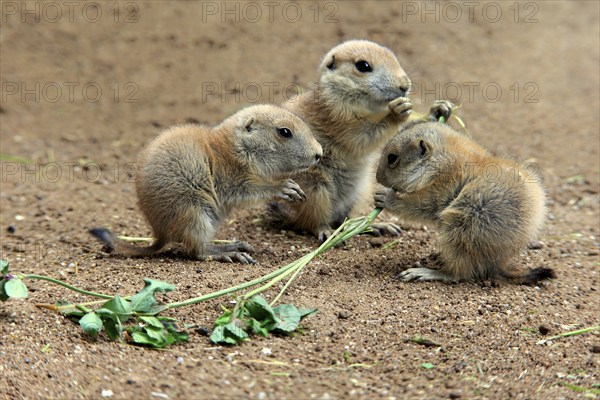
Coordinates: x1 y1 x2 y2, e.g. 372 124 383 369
273 40 412 241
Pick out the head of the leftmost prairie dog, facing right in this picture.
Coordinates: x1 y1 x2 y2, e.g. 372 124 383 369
231 105 323 178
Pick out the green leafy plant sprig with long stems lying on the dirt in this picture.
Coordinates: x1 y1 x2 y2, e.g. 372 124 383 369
0 209 381 348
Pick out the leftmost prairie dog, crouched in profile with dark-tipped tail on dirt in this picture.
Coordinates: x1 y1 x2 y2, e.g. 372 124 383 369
90 105 323 263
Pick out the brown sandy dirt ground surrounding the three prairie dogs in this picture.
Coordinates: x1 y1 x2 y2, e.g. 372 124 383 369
0 1 600 399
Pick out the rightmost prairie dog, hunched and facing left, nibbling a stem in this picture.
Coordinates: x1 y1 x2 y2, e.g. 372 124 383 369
375 102 554 284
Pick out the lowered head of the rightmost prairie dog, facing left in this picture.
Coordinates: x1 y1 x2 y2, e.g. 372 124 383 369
377 122 454 193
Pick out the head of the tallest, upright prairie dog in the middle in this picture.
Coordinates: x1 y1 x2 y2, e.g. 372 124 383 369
319 40 410 116
